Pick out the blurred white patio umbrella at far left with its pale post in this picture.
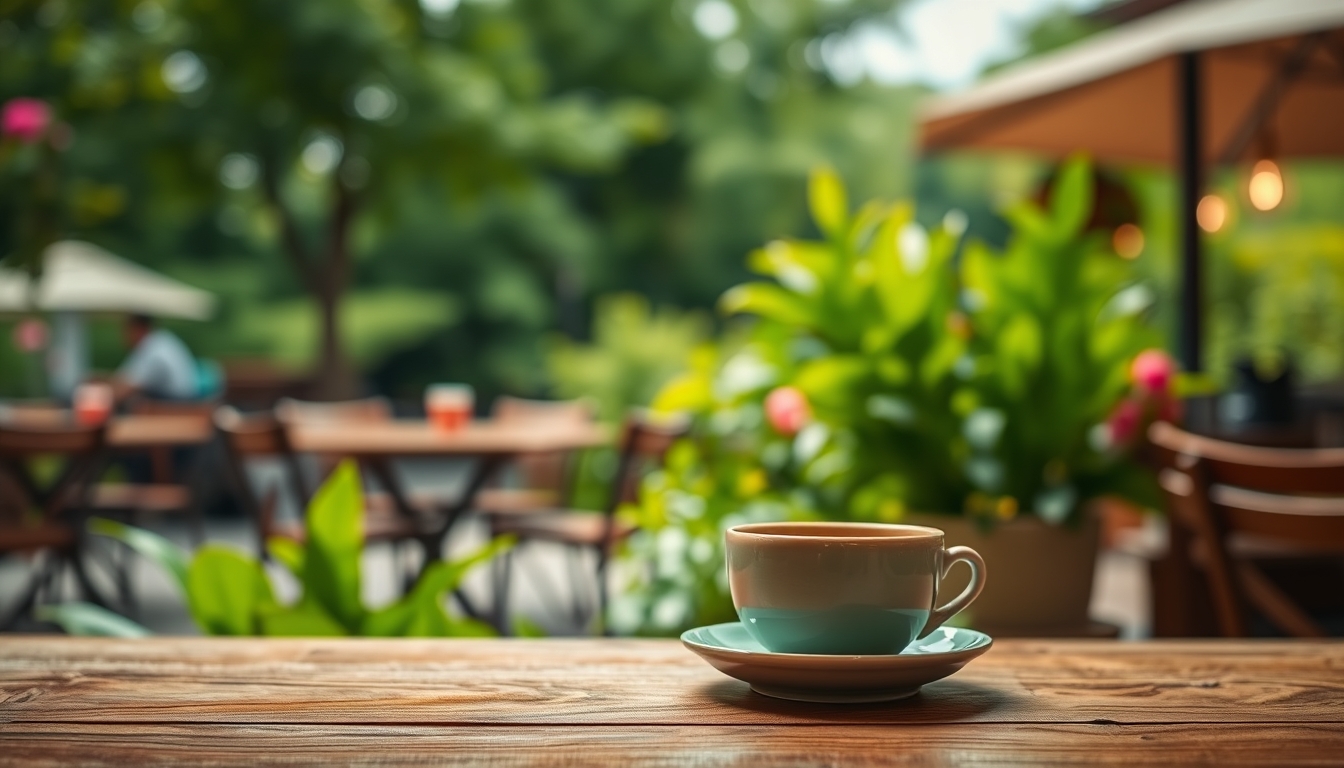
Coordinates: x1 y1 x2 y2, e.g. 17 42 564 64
0 241 215 397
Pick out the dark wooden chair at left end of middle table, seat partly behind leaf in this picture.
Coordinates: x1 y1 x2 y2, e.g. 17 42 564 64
215 406 434 575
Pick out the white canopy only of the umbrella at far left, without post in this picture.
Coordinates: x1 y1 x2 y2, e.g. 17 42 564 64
0 241 215 320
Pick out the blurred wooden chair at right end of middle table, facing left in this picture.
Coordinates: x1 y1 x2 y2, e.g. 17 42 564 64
488 413 691 631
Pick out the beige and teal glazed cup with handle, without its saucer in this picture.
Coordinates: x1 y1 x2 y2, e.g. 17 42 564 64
726 523 985 655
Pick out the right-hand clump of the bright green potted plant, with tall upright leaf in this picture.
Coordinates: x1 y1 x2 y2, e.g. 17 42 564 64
962 157 1160 522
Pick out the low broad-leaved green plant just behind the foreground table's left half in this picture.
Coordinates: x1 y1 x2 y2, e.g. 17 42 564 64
89 461 512 638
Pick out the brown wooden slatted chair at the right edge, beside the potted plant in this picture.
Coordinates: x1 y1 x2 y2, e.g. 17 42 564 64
1149 422 1344 638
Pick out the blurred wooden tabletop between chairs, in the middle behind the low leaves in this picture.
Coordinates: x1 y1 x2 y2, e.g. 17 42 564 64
289 420 610 457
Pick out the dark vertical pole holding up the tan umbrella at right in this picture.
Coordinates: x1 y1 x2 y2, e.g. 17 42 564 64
1176 51 1204 371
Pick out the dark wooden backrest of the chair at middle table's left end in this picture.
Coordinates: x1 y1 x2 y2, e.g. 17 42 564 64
214 406 312 554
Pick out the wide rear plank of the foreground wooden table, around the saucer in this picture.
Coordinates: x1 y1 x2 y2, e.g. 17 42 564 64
0 638 1344 731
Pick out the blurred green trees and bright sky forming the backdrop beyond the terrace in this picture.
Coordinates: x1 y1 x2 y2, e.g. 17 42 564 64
0 0 1344 408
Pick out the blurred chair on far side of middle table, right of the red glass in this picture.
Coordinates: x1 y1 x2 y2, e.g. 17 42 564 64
474 397 595 514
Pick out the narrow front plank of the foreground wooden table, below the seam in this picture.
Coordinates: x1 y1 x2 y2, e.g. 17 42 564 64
0 724 1344 767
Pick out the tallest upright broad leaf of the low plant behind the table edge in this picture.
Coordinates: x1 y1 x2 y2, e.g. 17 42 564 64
302 460 364 631
